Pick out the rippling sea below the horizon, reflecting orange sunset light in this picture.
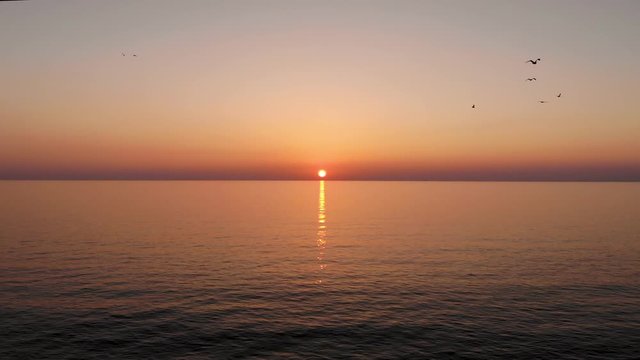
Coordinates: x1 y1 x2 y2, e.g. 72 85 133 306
0 182 640 359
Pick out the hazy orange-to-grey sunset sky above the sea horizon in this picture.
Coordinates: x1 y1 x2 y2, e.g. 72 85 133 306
0 0 640 180
